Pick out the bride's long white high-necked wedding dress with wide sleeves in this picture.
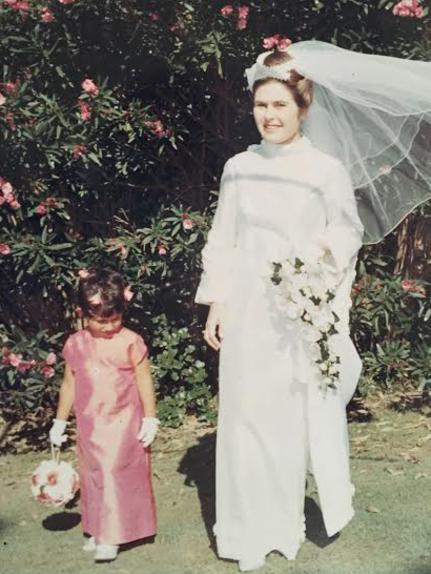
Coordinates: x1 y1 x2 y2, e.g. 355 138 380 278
196 137 363 561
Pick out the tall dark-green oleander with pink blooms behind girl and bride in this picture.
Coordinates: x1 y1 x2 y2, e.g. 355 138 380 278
0 0 430 444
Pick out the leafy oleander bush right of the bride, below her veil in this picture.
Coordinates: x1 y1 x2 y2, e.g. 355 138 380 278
351 255 431 394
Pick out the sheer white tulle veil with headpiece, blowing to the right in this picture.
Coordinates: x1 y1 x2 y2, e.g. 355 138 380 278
246 40 431 243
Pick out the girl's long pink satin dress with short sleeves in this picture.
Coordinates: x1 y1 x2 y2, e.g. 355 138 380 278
63 327 156 544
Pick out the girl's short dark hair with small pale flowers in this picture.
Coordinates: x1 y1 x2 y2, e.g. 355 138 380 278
78 269 126 318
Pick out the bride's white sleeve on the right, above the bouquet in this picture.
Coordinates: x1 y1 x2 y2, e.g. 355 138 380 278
321 161 364 274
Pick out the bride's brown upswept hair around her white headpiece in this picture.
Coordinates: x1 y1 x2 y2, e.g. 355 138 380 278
253 50 313 113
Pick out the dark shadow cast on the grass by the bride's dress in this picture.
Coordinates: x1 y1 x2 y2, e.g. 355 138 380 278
178 433 340 560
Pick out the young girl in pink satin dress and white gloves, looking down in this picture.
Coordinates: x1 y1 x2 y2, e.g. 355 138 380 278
49 271 159 562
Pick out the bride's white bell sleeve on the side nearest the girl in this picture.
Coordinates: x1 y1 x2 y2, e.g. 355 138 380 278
195 160 236 305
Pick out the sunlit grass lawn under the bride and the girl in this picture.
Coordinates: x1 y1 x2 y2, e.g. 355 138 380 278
0 410 431 574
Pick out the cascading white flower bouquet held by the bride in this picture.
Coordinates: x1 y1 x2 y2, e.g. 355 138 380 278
271 258 340 391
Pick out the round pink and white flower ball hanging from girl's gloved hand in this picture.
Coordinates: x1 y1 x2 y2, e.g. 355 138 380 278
31 460 79 506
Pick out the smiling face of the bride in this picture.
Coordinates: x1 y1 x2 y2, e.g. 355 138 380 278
253 80 301 144
